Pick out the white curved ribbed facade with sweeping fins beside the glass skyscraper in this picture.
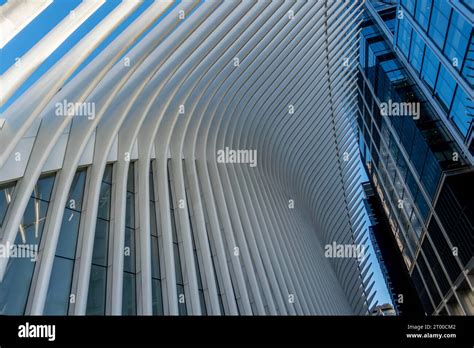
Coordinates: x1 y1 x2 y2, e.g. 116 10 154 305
0 0 373 315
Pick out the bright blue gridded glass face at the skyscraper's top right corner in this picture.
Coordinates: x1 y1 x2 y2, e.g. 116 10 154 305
394 0 474 144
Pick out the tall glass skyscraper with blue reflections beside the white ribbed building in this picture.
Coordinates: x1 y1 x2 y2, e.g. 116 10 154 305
358 0 474 315
